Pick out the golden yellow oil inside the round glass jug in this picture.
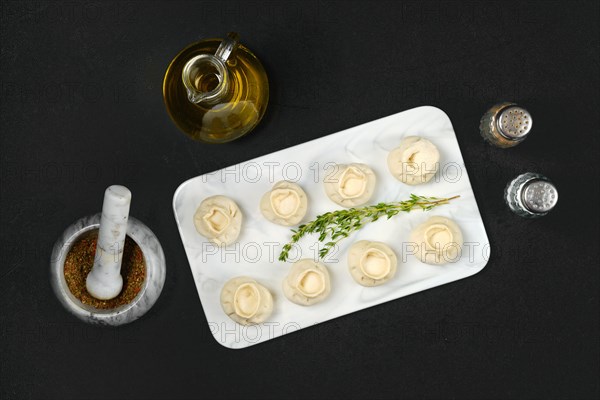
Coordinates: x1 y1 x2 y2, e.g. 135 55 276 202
163 39 269 143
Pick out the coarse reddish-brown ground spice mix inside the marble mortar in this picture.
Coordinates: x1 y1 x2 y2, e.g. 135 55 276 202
64 231 146 310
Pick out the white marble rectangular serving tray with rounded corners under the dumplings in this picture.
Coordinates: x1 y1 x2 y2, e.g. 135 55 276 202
173 106 490 348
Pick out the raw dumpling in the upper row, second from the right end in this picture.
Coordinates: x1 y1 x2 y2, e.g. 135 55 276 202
324 164 377 207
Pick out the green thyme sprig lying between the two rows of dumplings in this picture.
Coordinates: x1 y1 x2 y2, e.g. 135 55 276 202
279 194 460 261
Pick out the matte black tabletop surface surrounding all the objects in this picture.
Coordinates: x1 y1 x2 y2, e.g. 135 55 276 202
0 1 600 399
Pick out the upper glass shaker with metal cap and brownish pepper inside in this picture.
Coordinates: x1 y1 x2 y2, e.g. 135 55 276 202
479 102 533 148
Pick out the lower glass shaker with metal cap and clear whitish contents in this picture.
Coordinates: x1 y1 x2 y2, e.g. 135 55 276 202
504 172 558 218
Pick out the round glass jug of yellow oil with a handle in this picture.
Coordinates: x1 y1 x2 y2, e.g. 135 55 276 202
163 33 269 143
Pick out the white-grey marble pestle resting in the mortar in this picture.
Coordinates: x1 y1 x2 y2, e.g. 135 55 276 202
86 185 131 300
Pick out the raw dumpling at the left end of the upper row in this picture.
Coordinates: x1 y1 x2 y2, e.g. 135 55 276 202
194 196 242 246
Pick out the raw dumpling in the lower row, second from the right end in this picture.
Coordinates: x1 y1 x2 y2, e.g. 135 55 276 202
348 240 398 286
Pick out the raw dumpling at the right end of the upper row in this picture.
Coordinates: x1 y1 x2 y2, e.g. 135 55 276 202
388 136 440 185
